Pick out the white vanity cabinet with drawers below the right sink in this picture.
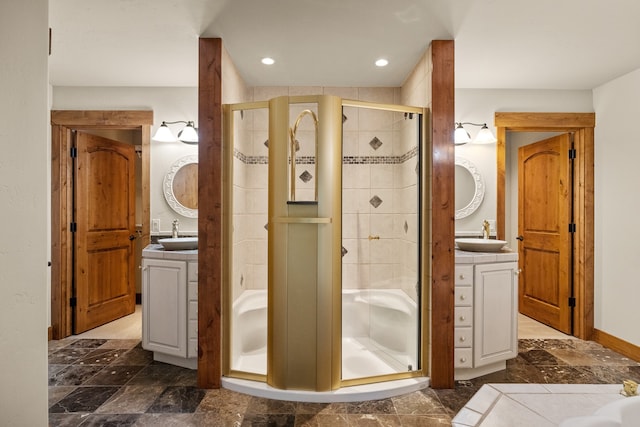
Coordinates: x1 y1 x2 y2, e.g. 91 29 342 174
454 251 518 380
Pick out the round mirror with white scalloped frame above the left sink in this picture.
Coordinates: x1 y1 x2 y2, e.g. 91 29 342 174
162 156 198 218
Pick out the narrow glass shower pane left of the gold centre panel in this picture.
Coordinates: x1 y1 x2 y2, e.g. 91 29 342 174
225 103 269 379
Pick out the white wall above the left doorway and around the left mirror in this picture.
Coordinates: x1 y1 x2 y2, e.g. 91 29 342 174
52 86 198 234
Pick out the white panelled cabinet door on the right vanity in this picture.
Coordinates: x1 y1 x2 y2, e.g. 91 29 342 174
473 262 518 367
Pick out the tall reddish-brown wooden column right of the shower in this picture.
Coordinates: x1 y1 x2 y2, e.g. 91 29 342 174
431 40 455 388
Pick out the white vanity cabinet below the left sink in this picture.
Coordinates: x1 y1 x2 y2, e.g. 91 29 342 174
142 245 198 369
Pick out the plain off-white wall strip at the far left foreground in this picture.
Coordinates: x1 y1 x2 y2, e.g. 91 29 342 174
0 0 49 426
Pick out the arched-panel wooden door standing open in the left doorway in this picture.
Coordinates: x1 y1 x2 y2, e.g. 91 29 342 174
73 132 136 334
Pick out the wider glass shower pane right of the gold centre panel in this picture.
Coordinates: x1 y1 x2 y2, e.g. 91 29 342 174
342 103 421 383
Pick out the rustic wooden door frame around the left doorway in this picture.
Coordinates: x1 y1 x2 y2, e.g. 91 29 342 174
49 110 153 339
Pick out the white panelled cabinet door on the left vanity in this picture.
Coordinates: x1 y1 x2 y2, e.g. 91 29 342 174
142 259 187 357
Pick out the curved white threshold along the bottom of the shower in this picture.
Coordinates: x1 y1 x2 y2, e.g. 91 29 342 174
222 377 429 403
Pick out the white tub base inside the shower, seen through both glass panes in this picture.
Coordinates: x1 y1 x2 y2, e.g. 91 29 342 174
231 289 418 379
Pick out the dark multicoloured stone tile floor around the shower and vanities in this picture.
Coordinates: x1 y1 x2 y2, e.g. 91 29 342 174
49 337 640 427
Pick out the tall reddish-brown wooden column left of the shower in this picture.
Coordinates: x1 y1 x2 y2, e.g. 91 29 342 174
198 38 222 388
